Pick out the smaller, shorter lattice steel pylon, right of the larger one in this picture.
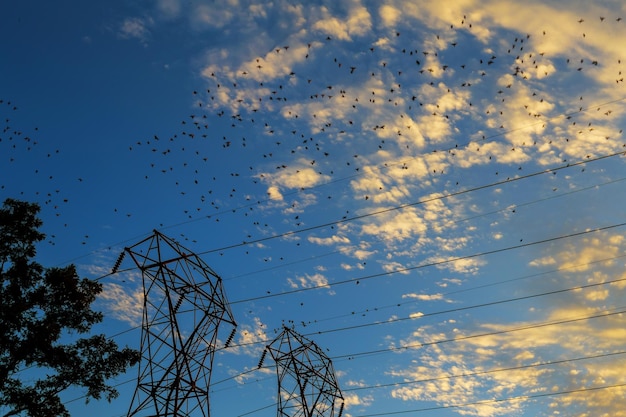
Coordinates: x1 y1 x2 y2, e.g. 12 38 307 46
259 327 344 417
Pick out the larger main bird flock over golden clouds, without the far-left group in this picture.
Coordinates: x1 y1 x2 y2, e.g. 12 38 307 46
119 13 623 240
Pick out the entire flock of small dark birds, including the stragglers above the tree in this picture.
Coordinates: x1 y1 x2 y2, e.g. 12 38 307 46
0 16 623 258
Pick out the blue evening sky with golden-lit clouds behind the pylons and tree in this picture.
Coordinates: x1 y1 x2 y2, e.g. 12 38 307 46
0 0 626 417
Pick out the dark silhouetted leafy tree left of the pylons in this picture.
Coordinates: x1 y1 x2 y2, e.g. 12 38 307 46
0 199 139 417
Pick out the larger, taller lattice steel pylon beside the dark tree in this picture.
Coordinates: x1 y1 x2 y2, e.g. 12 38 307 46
113 230 236 417
